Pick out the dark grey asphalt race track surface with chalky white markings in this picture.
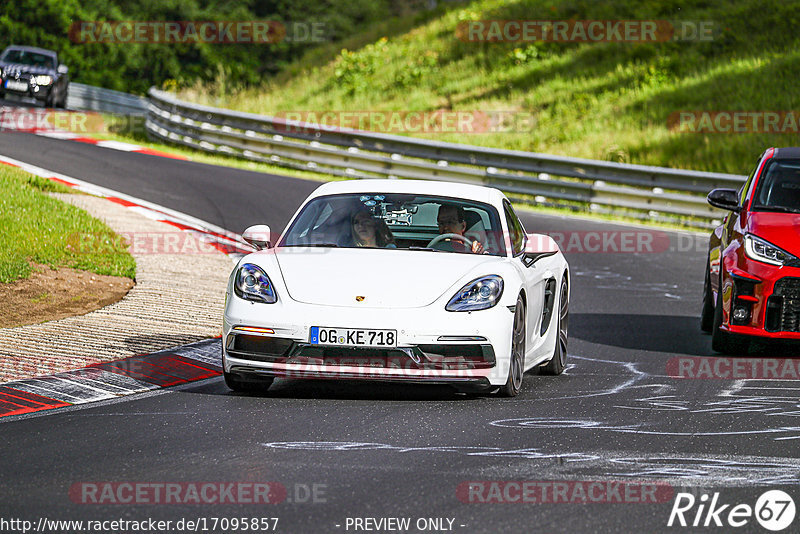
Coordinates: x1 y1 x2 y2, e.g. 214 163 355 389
0 133 800 533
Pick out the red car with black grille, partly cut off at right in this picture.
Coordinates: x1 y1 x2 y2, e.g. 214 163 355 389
701 148 800 354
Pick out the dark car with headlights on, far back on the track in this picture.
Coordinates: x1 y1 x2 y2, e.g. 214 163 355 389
0 45 69 108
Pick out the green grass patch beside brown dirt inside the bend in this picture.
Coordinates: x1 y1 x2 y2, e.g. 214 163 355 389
0 166 136 283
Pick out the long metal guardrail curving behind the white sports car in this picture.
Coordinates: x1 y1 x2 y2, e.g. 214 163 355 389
145 88 745 227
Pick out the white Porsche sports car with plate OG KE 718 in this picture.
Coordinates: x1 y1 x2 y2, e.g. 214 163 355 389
222 180 569 396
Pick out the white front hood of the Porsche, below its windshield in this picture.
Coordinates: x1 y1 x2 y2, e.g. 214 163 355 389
275 248 500 308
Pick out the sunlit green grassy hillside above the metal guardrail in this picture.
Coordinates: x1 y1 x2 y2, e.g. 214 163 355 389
181 0 800 174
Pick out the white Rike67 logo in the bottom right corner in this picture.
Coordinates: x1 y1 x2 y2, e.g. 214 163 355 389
667 490 796 532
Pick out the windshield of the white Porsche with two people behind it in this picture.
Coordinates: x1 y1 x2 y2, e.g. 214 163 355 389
278 193 505 256
